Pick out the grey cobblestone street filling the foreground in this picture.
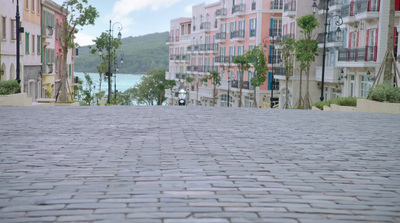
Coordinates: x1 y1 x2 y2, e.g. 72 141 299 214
0 107 400 223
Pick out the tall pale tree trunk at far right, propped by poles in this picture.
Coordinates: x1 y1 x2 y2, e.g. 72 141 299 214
383 0 395 84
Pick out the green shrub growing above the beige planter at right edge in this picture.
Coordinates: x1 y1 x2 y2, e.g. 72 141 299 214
368 84 400 103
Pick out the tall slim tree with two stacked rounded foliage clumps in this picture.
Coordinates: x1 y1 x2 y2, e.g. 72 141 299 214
296 14 319 109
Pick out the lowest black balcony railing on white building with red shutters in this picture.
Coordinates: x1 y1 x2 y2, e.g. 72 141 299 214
338 46 377 62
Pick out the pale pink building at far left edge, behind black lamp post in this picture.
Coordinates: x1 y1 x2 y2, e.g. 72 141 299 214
0 0 25 87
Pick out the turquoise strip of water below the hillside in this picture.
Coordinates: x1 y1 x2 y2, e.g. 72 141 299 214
74 72 144 92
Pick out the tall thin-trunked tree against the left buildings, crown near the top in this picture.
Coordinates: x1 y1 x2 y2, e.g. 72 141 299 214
56 0 99 103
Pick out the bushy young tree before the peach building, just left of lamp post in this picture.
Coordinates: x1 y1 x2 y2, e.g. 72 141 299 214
245 44 272 108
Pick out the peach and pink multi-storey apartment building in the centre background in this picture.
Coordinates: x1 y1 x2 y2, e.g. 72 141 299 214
166 0 283 107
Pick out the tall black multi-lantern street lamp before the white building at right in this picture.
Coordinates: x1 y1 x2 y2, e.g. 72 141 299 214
311 0 343 101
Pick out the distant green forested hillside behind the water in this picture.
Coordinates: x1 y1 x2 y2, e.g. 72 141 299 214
75 32 169 74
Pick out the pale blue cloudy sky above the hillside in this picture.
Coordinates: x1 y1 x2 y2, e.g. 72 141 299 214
53 0 219 46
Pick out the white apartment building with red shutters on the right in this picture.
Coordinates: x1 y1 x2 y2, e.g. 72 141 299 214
275 0 400 108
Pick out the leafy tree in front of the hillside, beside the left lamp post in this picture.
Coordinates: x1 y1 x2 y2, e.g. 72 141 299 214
89 32 122 104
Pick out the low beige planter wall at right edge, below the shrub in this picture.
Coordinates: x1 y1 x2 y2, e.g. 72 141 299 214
356 99 400 114
